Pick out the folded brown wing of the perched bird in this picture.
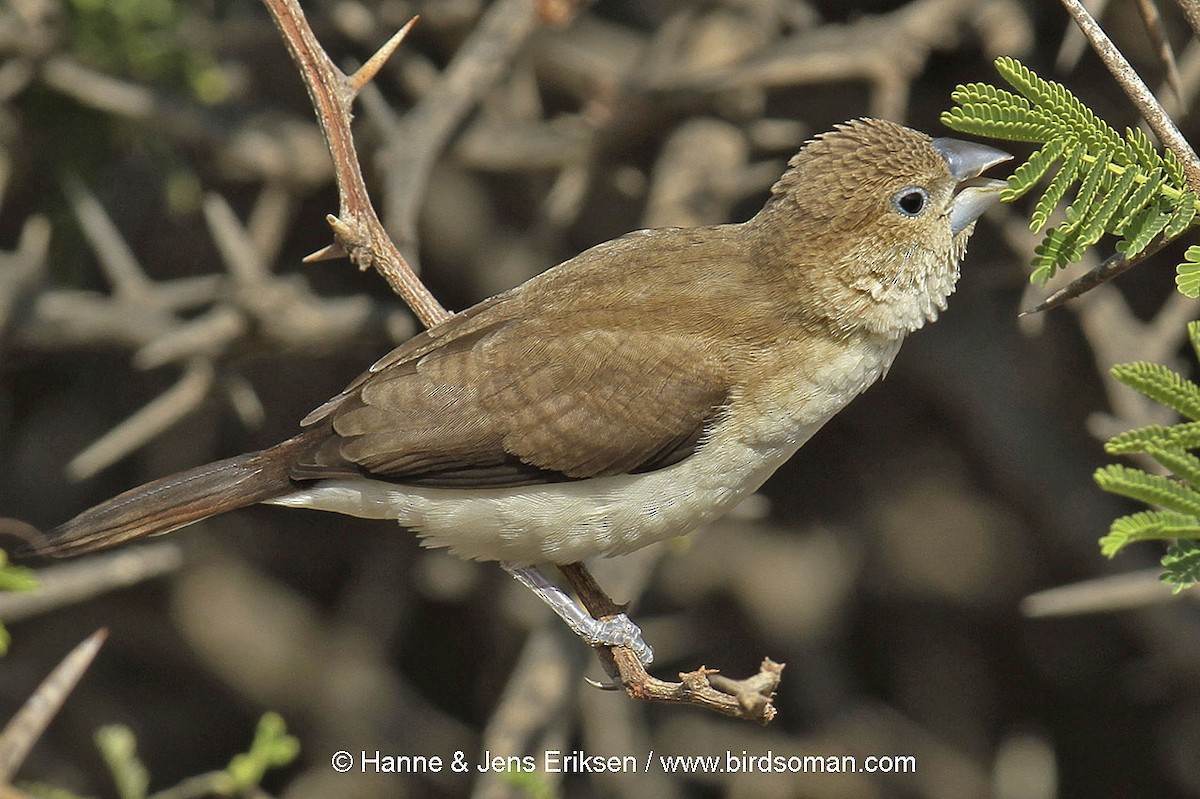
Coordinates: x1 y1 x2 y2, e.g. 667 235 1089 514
292 310 726 486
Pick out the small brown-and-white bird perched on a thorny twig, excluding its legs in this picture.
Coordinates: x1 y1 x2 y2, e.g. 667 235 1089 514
30 120 1003 561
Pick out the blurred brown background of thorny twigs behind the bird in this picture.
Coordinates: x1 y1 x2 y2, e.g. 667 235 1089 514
0 0 1200 799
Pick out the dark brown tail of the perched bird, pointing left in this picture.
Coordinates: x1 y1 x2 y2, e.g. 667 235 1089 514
32 435 306 558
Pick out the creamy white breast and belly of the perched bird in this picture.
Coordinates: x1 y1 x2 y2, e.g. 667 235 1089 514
271 341 900 565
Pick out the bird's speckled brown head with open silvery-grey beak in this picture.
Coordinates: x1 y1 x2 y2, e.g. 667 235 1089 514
750 119 1012 338
